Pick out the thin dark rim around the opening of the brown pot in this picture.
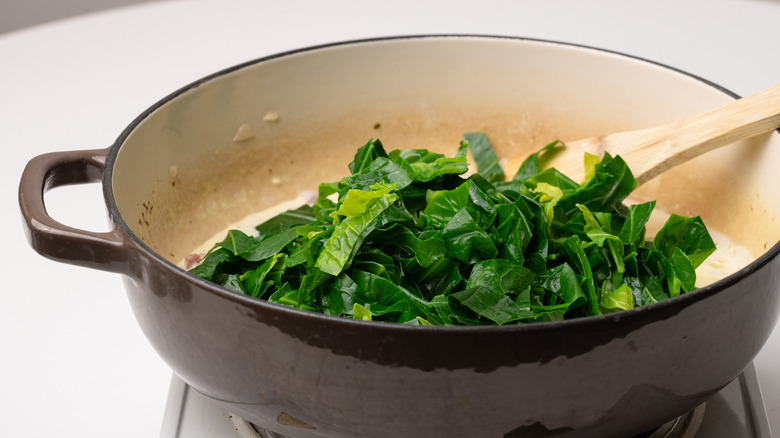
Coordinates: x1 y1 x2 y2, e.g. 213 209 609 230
102 34 780 333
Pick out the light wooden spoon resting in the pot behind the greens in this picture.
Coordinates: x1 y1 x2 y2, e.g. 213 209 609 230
504 84 780 185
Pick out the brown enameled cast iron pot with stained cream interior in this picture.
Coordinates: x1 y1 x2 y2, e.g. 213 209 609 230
19 36 780 438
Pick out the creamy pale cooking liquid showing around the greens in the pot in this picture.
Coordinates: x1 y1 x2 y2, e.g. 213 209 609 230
178 196 755 287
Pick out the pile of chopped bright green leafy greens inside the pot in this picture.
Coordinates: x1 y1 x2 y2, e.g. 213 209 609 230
190 133 715 325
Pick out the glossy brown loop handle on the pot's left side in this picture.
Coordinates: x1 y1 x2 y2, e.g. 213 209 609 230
19 149 134 274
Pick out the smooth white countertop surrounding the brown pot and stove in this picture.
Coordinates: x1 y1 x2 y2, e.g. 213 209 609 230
0 0 780 437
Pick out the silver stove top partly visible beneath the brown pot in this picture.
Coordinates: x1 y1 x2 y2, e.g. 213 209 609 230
160 364 772 438
